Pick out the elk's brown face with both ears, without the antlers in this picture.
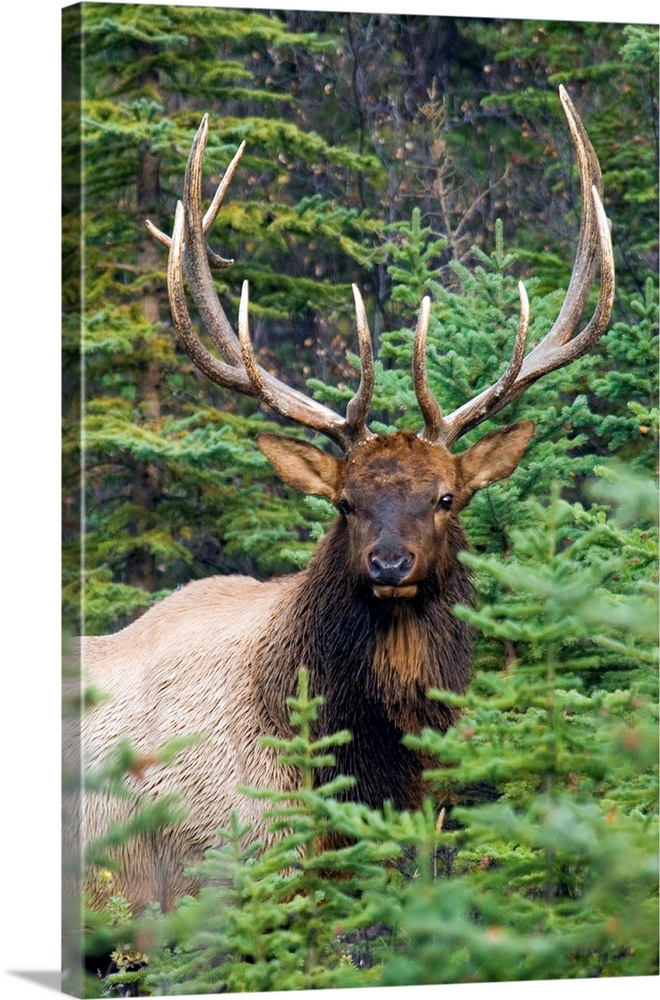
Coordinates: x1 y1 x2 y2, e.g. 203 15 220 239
258 421 534 600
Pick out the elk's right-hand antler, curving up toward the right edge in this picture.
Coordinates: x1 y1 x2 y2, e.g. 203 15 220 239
413 87 614 447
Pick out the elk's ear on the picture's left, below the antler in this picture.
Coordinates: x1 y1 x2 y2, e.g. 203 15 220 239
257 434 343 503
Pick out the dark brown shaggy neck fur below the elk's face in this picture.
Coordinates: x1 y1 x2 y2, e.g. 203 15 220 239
253 520 471 808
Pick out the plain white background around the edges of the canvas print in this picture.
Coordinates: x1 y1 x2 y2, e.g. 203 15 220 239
0 0 658 1000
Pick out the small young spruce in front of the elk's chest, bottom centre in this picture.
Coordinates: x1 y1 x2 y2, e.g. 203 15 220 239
142 669 400 995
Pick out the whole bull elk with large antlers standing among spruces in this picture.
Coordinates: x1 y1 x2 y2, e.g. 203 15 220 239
71 88 614 909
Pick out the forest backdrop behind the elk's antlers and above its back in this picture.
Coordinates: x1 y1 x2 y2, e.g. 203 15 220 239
64 4 658 632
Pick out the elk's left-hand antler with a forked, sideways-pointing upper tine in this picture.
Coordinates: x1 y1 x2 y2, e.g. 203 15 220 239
147 115 374 452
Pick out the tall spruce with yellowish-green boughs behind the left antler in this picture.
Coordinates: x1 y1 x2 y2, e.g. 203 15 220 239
65 4 384 632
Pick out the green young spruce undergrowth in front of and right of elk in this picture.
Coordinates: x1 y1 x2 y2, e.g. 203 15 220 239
69 470 658 996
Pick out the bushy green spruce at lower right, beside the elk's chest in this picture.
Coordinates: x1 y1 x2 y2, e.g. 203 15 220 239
383 479 658 985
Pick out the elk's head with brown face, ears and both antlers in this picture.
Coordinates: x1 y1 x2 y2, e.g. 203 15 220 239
147 87 614 599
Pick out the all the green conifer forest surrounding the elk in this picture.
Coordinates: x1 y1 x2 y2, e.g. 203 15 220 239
63 2 658 997
